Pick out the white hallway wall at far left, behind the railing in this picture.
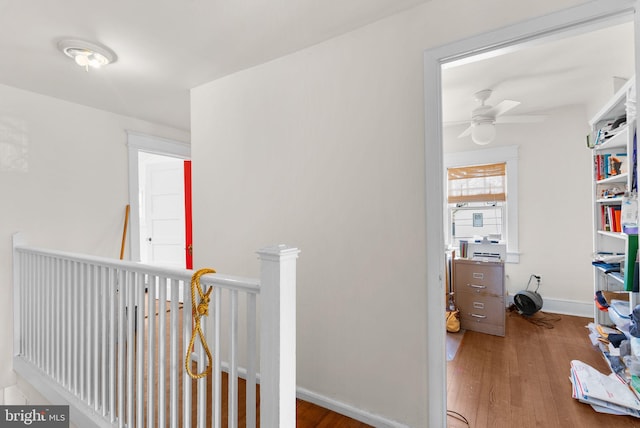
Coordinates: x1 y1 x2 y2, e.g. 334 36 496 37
0 85 189 404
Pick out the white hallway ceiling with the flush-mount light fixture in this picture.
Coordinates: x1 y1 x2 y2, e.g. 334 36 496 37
0 0 427 130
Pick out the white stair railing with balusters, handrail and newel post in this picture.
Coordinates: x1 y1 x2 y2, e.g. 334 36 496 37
13 234 299 428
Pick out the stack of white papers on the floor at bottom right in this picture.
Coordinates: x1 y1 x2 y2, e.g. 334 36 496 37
570 360 640 418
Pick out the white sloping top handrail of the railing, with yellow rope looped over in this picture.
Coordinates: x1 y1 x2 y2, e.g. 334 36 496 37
15 245 260 294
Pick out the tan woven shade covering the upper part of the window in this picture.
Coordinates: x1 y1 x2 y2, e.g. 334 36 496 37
447 162 507 204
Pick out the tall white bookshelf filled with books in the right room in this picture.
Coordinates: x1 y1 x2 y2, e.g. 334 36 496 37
588 77 638 324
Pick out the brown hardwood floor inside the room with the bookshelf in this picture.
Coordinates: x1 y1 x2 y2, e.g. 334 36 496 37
447 312 640 428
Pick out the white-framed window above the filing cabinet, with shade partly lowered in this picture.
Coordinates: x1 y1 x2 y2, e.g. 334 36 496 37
444 146 519 263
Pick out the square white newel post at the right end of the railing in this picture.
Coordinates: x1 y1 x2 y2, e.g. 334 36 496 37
258 245 300 428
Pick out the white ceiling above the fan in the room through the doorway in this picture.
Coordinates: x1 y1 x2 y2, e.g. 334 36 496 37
442 22 634 129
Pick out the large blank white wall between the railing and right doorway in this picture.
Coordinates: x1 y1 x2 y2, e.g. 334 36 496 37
191 0 583 426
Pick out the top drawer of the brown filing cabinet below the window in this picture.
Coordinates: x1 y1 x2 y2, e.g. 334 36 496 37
454 260 504 296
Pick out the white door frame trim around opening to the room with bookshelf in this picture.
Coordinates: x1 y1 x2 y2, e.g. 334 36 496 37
424 1 639 426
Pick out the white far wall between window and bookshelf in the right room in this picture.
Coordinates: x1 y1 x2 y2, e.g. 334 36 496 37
444 106 593 316
